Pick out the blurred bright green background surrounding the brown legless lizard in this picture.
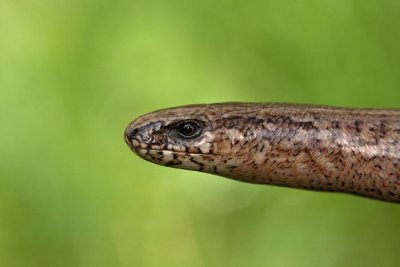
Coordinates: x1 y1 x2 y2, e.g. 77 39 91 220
0 0 400 267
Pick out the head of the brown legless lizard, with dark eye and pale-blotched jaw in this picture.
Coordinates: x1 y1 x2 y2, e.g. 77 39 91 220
124 105 219 170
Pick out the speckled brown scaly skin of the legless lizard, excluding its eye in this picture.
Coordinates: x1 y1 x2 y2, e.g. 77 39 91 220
125 103 400 203
